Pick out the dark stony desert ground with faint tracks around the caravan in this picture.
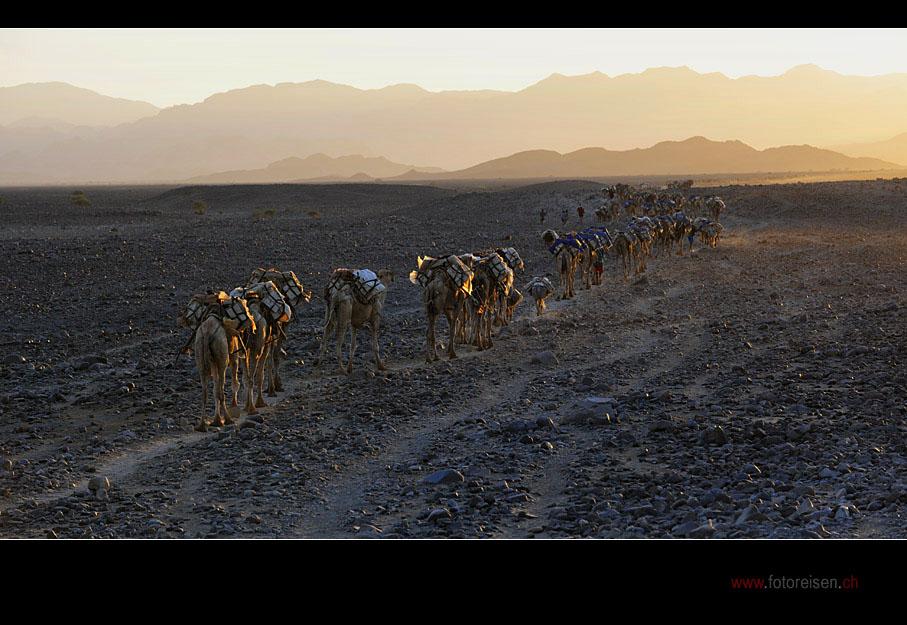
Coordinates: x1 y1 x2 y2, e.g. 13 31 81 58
0 179 907 538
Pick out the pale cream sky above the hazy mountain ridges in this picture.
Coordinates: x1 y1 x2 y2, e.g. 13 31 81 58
0 28 907 107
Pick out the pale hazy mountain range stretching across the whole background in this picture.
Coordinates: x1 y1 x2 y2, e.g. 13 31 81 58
0 65 907 181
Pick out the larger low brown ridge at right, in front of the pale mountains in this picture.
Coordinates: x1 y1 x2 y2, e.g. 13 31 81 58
395 137 901 180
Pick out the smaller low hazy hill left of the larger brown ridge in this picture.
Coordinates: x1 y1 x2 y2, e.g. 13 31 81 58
186 154 444 184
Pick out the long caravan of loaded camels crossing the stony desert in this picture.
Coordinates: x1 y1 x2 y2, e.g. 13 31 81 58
177 184 725 431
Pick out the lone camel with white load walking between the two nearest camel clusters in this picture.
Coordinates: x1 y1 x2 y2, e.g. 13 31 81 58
316 269 395 375
